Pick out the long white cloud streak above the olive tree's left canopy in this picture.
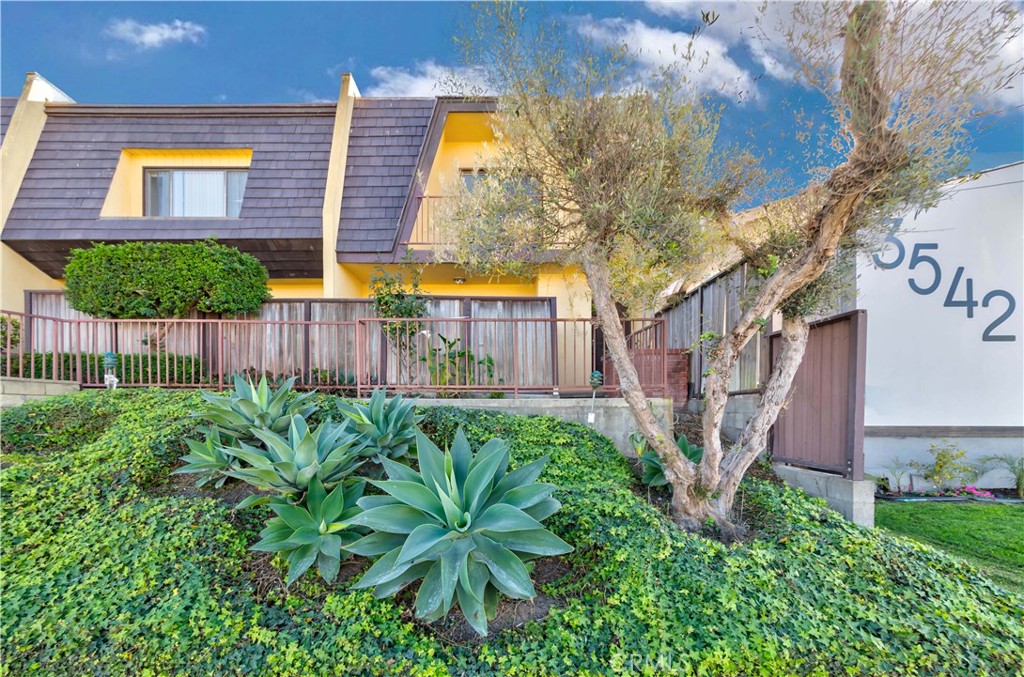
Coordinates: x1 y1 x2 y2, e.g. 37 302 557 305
577 16 760 101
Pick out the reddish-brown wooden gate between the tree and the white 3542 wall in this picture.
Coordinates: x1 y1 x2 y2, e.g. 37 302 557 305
771 310 867 479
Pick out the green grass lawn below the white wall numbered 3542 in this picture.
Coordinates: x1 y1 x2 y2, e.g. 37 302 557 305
874 502 1024 592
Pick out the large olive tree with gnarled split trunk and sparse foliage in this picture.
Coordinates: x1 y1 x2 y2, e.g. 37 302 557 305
438 2 1020 536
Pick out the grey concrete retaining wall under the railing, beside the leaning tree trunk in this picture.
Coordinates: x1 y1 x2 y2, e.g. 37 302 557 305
419 397 672 457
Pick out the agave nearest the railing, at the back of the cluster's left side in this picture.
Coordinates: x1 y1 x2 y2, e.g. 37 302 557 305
196 375 316 442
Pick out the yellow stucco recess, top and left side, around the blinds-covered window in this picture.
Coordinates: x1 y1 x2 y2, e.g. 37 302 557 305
99 149 253 217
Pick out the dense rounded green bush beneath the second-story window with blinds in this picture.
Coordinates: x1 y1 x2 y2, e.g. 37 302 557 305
65 241 270 319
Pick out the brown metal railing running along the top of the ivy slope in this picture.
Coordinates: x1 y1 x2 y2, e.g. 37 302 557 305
0 311 668 396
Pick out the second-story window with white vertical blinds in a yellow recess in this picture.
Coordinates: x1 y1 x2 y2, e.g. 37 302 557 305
144 169 249 217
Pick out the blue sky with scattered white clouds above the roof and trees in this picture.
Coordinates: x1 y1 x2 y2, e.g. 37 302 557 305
6 2 1024 174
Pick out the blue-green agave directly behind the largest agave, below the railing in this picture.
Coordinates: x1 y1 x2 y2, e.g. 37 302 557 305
338 388 423 459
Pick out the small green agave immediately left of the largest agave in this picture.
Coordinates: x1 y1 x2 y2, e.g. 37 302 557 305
252 475 364 585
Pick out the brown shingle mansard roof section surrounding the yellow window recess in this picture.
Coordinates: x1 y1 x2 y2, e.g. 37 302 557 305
3 104 335 277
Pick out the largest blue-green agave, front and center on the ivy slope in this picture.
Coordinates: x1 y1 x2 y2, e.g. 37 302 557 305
348 429 572 635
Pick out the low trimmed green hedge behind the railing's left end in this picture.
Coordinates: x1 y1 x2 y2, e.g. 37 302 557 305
0 352 208 385
